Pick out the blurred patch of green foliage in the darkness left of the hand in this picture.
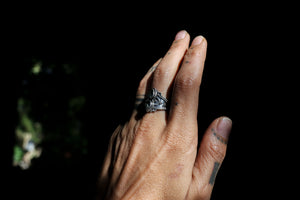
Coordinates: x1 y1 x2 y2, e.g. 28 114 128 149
13 56 88 169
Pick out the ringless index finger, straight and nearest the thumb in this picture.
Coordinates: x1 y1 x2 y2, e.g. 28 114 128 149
169 36 207 124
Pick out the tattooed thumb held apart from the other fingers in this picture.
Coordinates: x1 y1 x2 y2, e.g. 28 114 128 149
192 117 232 198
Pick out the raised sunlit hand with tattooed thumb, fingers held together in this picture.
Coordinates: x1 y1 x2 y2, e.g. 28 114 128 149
100 31 232 200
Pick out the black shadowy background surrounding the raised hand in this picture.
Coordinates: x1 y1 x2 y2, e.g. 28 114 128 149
5 4 295 199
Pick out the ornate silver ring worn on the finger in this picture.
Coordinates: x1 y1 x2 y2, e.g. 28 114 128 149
145 88 168 112
